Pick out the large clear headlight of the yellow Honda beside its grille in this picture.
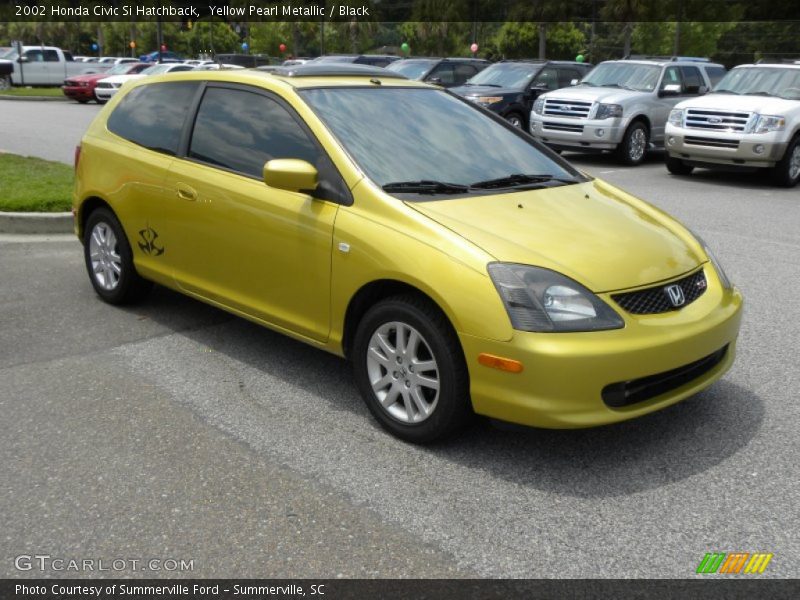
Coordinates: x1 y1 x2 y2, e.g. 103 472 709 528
488 263 625 332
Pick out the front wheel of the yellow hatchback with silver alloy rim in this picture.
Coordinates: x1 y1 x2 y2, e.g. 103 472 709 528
351 295 472 444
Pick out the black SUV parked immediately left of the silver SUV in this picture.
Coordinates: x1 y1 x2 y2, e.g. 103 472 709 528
452 60 592 131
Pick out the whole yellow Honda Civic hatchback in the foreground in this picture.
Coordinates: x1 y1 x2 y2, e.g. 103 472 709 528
74 65 742 443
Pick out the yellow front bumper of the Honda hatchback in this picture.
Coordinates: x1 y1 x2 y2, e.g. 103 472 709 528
460 264 742 429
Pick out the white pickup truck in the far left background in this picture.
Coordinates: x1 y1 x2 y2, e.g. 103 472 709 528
0 46 113 89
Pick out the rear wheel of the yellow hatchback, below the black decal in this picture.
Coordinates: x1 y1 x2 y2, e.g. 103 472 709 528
83 208 153 304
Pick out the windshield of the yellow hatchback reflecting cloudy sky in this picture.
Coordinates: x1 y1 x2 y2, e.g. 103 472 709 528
301 87 580 193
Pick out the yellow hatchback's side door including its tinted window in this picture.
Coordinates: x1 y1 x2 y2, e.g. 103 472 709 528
168 83 343 341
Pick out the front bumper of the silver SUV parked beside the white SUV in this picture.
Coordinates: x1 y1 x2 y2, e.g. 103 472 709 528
531 113 628 150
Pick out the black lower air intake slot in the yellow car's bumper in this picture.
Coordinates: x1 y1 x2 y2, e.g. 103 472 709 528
602 345 728 408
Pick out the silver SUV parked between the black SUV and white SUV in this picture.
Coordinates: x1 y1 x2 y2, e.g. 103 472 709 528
530 58 725 165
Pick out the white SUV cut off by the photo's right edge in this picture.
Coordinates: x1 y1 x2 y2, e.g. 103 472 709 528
666 64 800 187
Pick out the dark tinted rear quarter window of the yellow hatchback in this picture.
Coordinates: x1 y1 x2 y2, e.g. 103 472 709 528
108 81 198 154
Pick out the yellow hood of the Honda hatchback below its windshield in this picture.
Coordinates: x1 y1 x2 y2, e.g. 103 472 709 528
407 179 705 292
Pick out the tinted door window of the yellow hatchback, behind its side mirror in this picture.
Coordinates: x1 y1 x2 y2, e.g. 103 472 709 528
189 88 320 179
